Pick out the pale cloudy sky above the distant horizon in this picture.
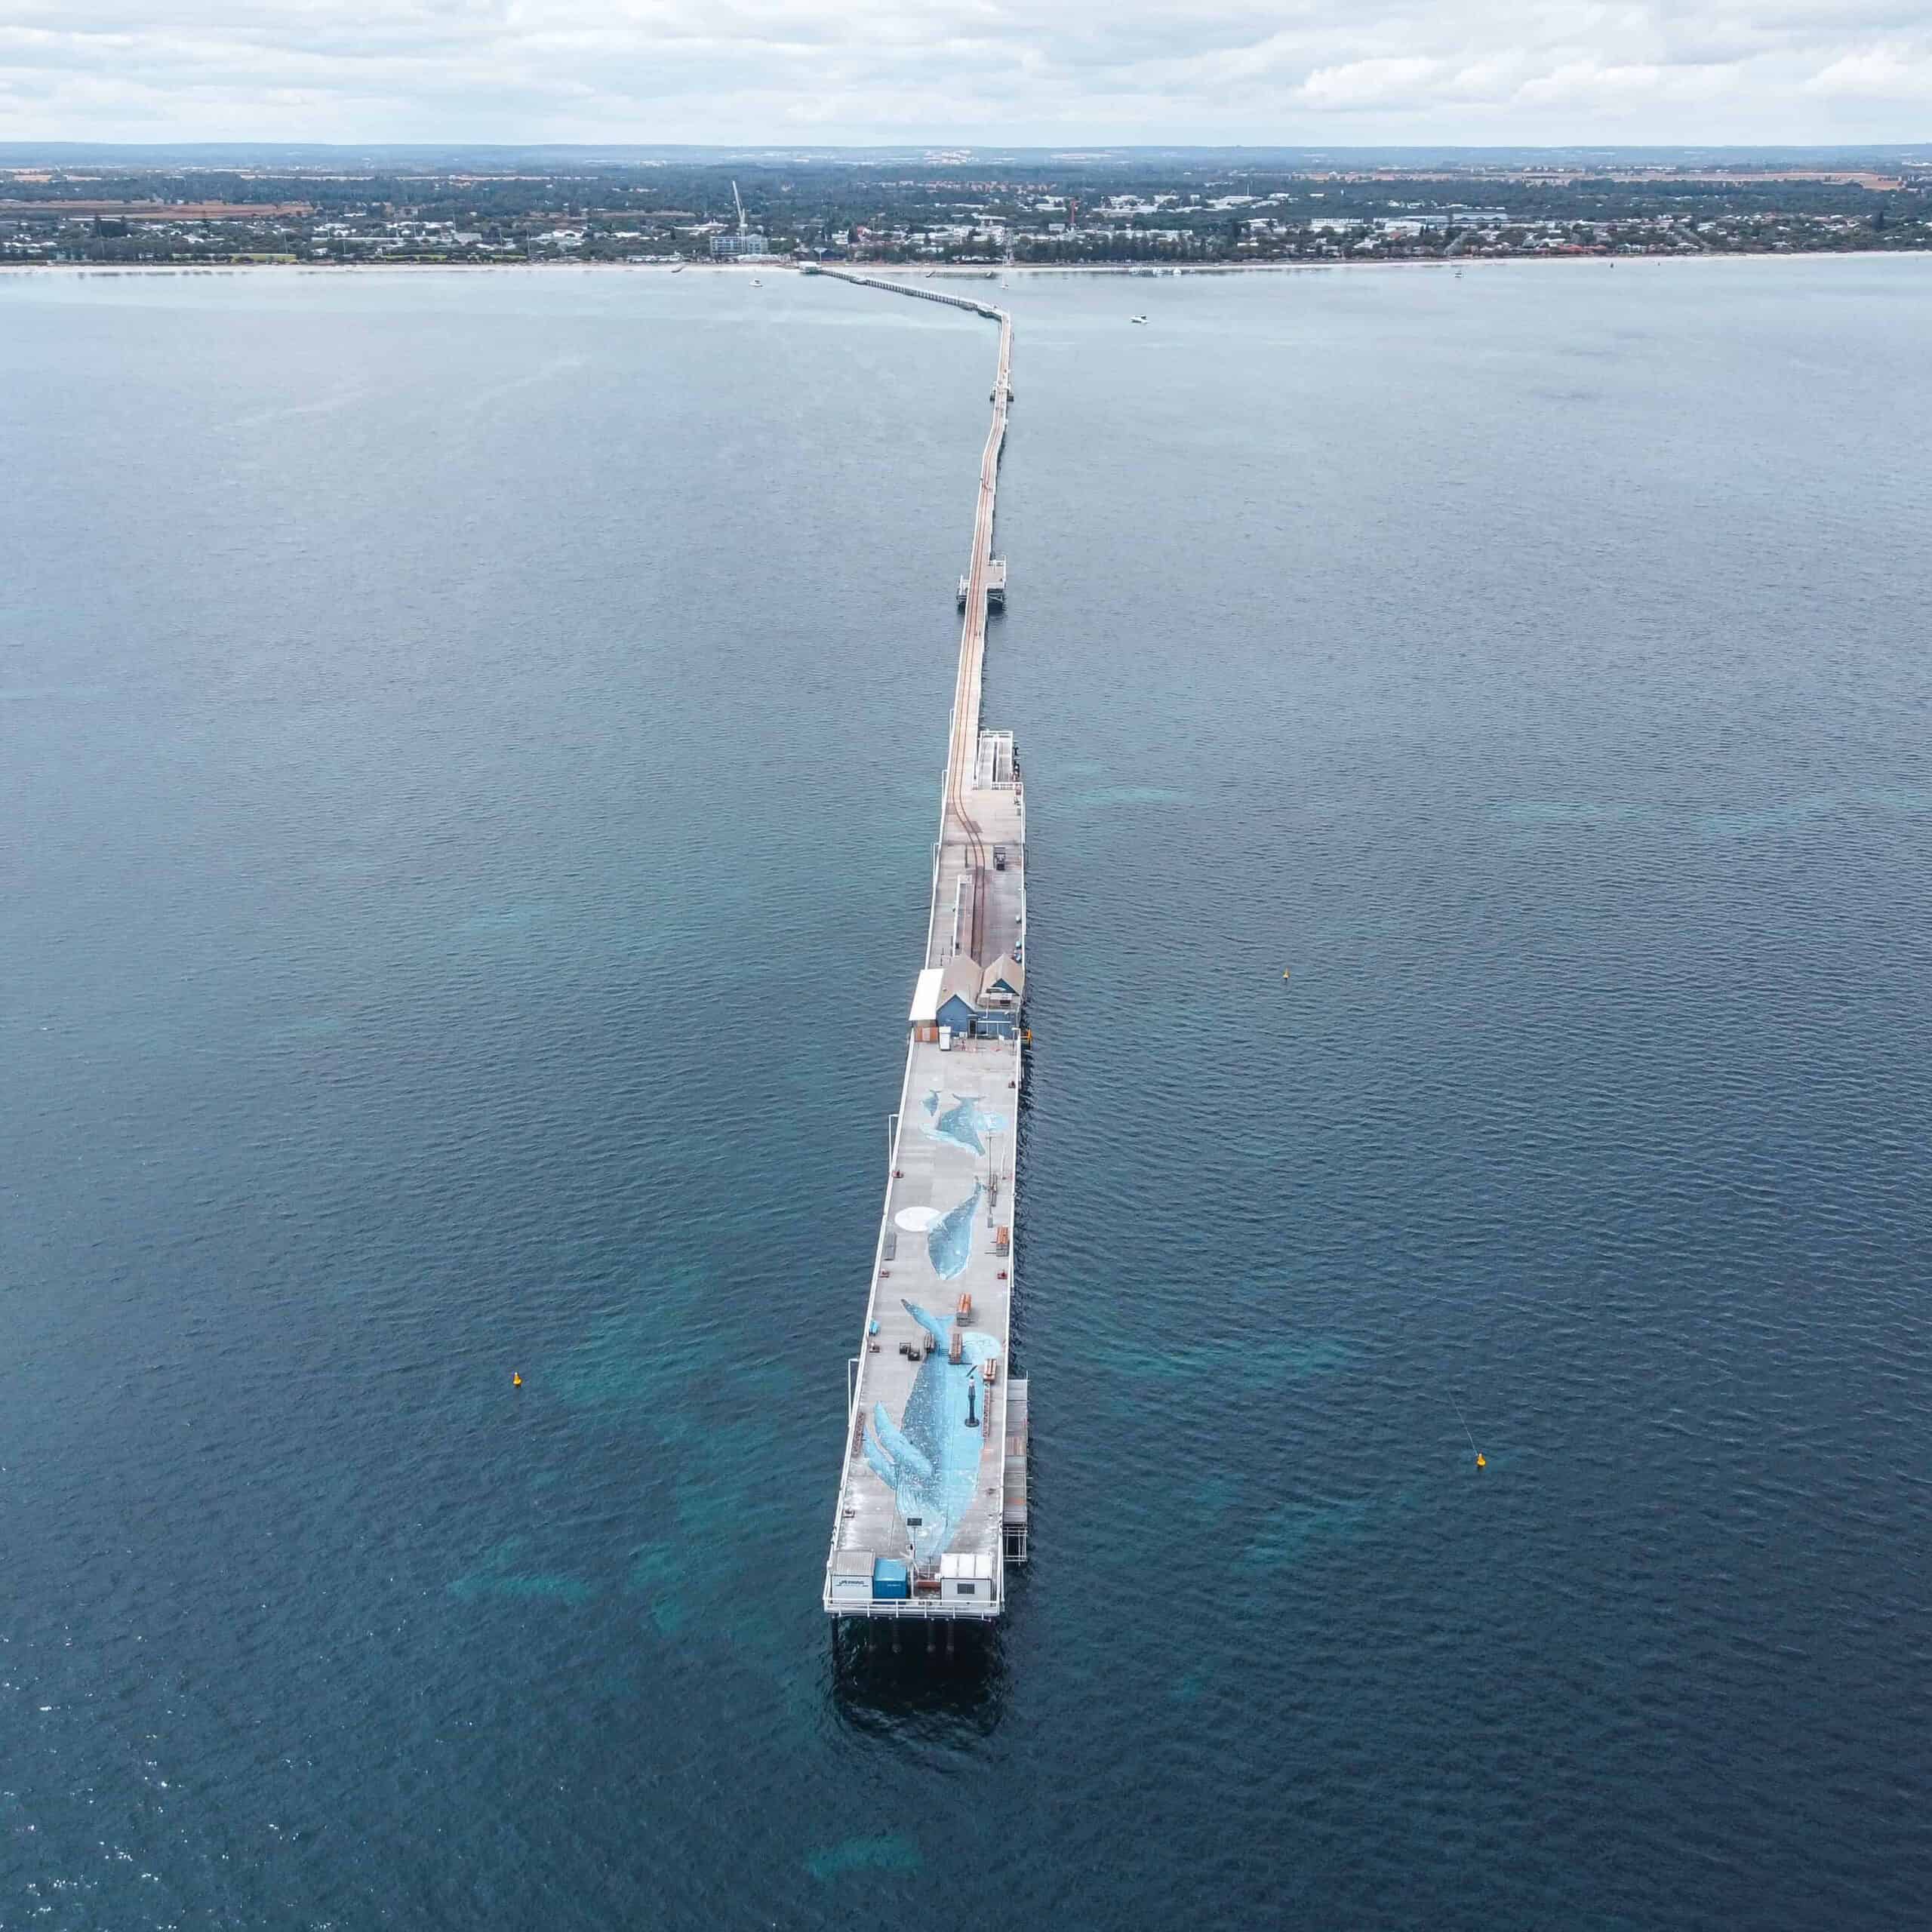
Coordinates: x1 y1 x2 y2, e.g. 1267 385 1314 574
0 0 1932 147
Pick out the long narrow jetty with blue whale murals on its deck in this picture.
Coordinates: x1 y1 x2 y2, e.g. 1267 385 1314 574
806 265 1028 1640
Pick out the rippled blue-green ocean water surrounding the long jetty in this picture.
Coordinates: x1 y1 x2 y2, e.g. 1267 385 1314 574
0 259 1932 1932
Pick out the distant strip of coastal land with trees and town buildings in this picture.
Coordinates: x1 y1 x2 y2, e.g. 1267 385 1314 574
0 149 1932 265
